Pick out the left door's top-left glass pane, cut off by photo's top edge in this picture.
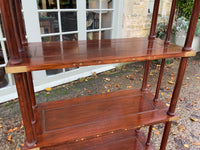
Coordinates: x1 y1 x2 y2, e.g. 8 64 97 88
37 0 57 9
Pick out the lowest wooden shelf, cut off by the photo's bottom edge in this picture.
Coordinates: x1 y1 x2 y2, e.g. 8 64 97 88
41 130 155 150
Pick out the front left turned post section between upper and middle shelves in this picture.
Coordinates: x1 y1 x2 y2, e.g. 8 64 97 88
14 73 36 147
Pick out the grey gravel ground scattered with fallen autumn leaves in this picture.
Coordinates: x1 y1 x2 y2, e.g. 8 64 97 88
0 55 200 150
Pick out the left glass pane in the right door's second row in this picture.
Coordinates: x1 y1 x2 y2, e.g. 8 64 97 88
86 12 99 30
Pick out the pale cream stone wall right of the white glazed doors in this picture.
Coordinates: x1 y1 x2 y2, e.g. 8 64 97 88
122 0 171 38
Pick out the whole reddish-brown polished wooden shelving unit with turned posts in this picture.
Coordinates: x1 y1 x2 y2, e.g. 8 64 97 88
0 0 200 150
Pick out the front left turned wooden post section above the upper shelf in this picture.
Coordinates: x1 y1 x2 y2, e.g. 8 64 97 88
0 0 22 64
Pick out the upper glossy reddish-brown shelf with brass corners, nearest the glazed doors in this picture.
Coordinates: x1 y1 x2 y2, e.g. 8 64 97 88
6 38 196 73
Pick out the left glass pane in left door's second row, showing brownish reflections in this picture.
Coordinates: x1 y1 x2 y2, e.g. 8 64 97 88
39 12 59 34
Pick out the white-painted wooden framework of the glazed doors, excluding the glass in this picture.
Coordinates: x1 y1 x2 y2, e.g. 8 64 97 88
0 0 123 103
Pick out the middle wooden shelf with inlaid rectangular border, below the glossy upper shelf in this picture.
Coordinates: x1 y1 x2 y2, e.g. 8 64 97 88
31 89 177 147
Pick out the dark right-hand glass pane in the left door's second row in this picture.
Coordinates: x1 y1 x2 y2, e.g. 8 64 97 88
61 12 77 32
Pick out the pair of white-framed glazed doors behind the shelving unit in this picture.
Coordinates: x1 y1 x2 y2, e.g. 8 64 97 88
22 0 123 90
